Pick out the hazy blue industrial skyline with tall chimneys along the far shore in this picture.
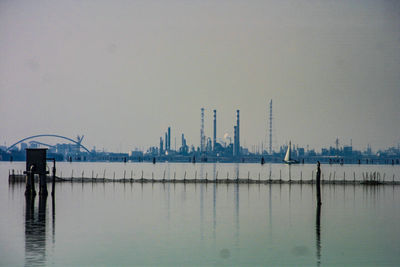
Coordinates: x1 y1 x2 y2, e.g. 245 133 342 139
0 100 400 164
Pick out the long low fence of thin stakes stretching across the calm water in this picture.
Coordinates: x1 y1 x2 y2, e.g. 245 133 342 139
9 169 400 185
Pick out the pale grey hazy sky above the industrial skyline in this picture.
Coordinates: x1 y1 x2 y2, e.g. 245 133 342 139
0 0 400 152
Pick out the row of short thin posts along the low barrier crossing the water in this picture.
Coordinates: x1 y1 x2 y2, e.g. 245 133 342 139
9 169 400 183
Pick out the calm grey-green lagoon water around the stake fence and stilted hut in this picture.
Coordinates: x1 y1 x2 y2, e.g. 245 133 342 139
0 162 400 266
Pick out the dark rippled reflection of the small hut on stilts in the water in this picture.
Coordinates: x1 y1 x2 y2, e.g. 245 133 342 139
25 195 47 266
